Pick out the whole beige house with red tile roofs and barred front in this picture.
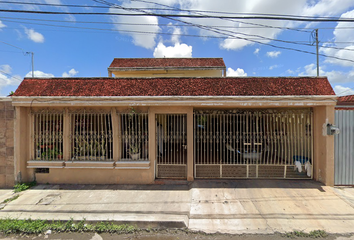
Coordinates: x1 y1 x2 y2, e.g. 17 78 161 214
12 58 336 185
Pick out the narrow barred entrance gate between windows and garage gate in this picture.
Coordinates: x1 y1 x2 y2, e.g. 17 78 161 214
156 114 187 179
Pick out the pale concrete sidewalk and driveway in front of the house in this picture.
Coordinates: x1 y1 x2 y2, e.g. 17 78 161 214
0 180 354 234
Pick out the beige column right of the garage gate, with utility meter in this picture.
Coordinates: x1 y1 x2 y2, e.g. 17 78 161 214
313 106 334 186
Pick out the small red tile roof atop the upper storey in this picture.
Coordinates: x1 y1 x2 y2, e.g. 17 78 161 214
109 58 225 68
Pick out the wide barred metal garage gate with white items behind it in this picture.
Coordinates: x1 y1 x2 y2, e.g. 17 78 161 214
194 108 313 179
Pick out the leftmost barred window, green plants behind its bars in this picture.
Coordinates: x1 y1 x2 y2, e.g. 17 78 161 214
32 110 64 161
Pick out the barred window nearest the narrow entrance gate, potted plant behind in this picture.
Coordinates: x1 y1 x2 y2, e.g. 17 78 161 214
118 112 149 161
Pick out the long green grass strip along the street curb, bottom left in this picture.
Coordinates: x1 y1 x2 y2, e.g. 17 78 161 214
0 219 139 234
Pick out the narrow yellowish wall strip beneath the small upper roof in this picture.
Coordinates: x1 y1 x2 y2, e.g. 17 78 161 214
109 70 223 78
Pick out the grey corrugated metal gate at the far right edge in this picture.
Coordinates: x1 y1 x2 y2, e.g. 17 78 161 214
334 110 354 185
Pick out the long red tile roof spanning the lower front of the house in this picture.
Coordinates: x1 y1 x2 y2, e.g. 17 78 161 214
13 77 335 96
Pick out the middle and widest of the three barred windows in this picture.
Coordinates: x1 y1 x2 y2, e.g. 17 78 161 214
69 110 113 161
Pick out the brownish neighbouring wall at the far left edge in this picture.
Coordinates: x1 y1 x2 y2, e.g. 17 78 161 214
0 98 15 188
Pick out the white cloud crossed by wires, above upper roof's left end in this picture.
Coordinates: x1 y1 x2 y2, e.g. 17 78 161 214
109 1 160 49
